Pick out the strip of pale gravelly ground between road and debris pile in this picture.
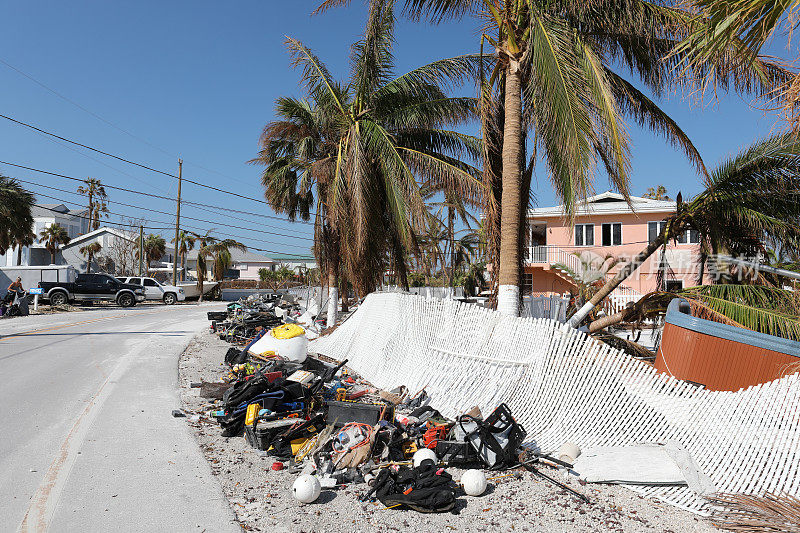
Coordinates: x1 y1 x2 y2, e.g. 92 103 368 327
180 332 717 533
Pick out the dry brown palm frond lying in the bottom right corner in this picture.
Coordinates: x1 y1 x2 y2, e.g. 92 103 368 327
708 493 800 533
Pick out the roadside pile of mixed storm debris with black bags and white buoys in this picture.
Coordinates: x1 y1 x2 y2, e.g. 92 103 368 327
194 310 589 513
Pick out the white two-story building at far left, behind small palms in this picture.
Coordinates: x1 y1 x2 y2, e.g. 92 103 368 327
0 204 89 266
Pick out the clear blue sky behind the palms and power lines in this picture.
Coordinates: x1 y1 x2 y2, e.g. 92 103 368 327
0 0 788 255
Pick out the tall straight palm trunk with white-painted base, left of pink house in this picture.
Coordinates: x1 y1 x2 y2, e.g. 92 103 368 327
497 66 522 316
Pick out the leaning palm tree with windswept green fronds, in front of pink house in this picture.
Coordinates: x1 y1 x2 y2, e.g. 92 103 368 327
570 134 800 326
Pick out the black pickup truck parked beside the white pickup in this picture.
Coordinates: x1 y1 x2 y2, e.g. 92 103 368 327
39 274 144 307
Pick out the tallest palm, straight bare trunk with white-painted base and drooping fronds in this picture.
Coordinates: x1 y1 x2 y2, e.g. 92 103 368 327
390 0 786 314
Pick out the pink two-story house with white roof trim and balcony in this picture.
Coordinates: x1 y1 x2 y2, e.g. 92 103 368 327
522 191 699 300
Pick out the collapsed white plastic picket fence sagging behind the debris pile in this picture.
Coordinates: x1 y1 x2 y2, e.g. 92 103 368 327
312 293 800 514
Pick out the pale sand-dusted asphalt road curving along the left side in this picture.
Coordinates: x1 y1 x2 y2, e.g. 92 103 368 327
0 304 241 532
